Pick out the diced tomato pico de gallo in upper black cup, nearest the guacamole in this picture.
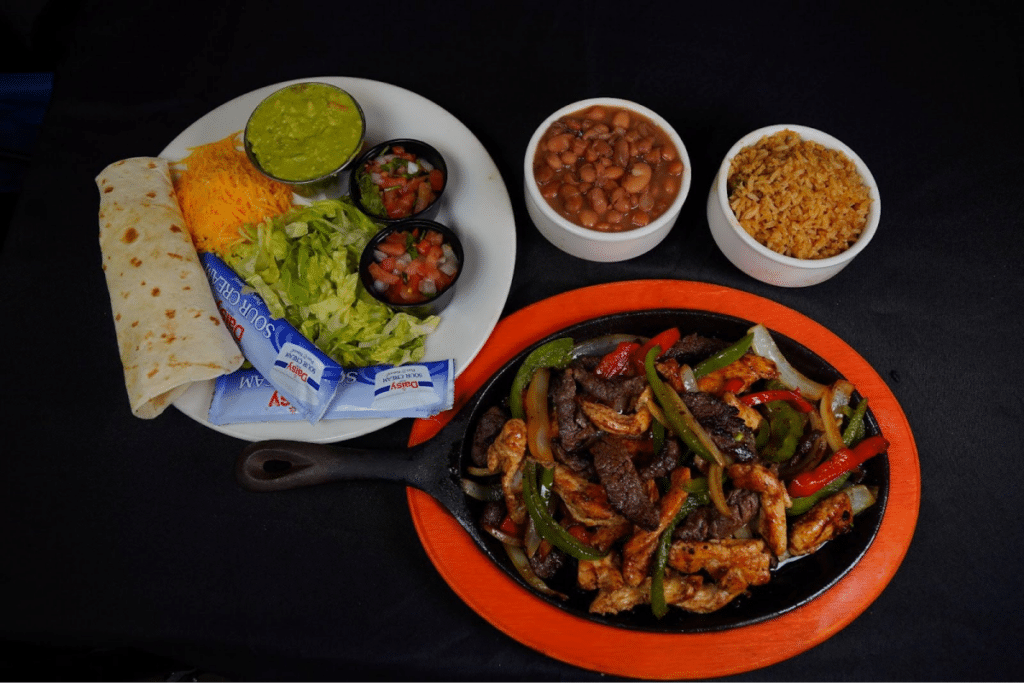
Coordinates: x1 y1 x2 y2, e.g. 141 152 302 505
358 145 444 218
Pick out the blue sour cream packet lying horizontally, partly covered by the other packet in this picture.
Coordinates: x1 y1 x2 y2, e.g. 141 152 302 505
209 359 455 425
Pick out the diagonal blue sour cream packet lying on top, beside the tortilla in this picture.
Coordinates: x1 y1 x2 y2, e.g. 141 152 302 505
200 253 344 424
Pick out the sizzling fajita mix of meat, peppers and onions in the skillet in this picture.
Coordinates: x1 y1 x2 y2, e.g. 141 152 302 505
463 325 889 618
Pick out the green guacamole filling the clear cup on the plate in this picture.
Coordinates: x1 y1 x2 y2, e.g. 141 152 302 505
246 83 362 182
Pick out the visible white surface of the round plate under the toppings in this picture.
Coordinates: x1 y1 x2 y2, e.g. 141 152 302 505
160 77 516 443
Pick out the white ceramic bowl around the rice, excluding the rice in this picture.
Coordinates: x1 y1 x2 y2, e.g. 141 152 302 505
708 125 882 287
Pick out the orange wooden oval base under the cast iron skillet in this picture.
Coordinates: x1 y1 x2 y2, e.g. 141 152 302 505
408 280 921 679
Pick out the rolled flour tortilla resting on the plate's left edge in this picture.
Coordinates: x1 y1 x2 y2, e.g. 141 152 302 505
96 157 245 419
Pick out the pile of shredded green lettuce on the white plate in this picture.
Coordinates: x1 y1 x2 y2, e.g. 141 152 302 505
225 197 440 368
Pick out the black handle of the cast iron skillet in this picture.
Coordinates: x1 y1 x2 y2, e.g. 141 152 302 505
234 440 422 492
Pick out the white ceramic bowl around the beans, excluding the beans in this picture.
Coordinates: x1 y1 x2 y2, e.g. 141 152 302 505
523 97 692 262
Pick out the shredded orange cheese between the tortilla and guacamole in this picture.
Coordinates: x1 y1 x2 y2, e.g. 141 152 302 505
174 131 292 256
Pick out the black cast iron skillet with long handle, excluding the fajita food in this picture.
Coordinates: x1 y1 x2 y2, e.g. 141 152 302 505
236 309 889 633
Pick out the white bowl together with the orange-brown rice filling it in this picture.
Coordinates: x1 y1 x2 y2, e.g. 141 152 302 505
708 125 882 287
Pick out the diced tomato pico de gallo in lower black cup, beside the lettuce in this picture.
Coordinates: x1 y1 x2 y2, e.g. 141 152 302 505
368 227 460 305
